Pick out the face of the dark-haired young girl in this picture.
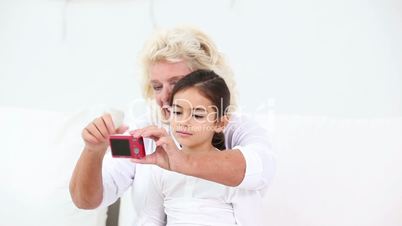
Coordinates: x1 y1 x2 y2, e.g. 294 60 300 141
170 87 223 151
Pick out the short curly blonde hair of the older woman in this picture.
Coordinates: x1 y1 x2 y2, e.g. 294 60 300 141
140 26 236 107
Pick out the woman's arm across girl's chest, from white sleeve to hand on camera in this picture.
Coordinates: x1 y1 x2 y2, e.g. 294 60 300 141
132 117 275 187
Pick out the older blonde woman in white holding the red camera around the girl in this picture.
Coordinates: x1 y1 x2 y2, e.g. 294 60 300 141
70 28 274 225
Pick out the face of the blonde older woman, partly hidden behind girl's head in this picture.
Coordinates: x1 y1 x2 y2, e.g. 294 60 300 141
149 61 191 113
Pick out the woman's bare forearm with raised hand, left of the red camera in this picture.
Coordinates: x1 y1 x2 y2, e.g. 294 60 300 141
69 114 128 209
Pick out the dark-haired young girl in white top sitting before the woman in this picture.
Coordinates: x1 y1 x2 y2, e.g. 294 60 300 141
135 70 261 226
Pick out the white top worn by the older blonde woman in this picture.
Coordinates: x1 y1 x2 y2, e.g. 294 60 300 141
101 111 275 226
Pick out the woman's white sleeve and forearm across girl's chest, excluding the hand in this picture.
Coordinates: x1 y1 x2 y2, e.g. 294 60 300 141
184 115 275 190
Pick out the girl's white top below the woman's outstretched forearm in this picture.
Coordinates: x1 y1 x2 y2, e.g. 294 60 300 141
135 166 239 226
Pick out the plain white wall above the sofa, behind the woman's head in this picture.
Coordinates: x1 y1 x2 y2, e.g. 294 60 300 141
0 0 402 117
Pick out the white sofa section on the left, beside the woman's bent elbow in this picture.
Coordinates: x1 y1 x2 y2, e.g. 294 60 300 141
0 107 107 226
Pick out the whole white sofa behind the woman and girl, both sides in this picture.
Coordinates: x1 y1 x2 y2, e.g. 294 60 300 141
0 107 402 226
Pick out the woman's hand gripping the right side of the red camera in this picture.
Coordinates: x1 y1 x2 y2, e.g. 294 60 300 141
130 126 188 172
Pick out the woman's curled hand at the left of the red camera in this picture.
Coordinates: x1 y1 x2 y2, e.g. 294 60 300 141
82 114 128 152
